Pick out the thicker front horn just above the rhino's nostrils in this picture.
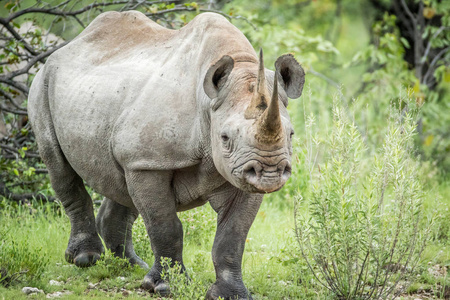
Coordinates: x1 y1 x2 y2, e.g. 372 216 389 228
256 74 283 144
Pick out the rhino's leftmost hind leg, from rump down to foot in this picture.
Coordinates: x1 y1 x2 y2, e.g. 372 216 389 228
28 83 104 267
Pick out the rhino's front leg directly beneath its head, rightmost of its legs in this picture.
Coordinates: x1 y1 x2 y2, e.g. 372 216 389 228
206 185 263 299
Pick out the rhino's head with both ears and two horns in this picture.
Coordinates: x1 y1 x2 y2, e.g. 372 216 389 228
203 51 305 193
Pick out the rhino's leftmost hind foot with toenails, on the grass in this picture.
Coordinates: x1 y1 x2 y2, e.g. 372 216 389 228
65 235 104 268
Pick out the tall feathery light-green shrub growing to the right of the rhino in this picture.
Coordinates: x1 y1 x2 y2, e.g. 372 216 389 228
296 93 427 299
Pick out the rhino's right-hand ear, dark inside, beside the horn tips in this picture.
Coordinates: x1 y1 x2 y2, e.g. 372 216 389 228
275 54 305 99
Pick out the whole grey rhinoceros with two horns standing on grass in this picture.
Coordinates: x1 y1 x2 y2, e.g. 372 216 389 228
28 11 305 299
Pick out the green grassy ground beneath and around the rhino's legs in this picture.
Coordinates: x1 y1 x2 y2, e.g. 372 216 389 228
0 179 450 299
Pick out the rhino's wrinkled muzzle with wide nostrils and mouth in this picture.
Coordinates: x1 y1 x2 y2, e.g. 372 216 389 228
233 159 291 193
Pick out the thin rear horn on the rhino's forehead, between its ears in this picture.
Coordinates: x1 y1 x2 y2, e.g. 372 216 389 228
245 49 267 119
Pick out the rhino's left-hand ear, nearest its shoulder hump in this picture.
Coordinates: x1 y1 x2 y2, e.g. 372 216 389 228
203 55 234 99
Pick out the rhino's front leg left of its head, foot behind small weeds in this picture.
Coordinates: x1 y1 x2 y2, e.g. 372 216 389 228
126 171 185 296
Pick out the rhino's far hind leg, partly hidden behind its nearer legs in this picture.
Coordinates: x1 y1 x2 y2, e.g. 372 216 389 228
95 198 148 269
